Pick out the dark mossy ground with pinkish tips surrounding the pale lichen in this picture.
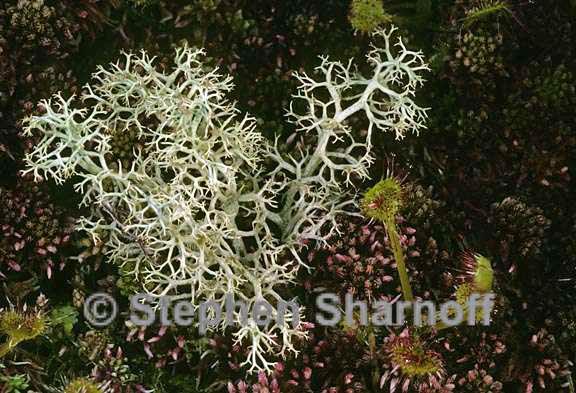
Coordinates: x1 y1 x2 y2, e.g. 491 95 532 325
0 0 576 393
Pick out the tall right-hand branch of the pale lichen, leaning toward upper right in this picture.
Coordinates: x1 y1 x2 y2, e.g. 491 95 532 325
273 27 428 250
